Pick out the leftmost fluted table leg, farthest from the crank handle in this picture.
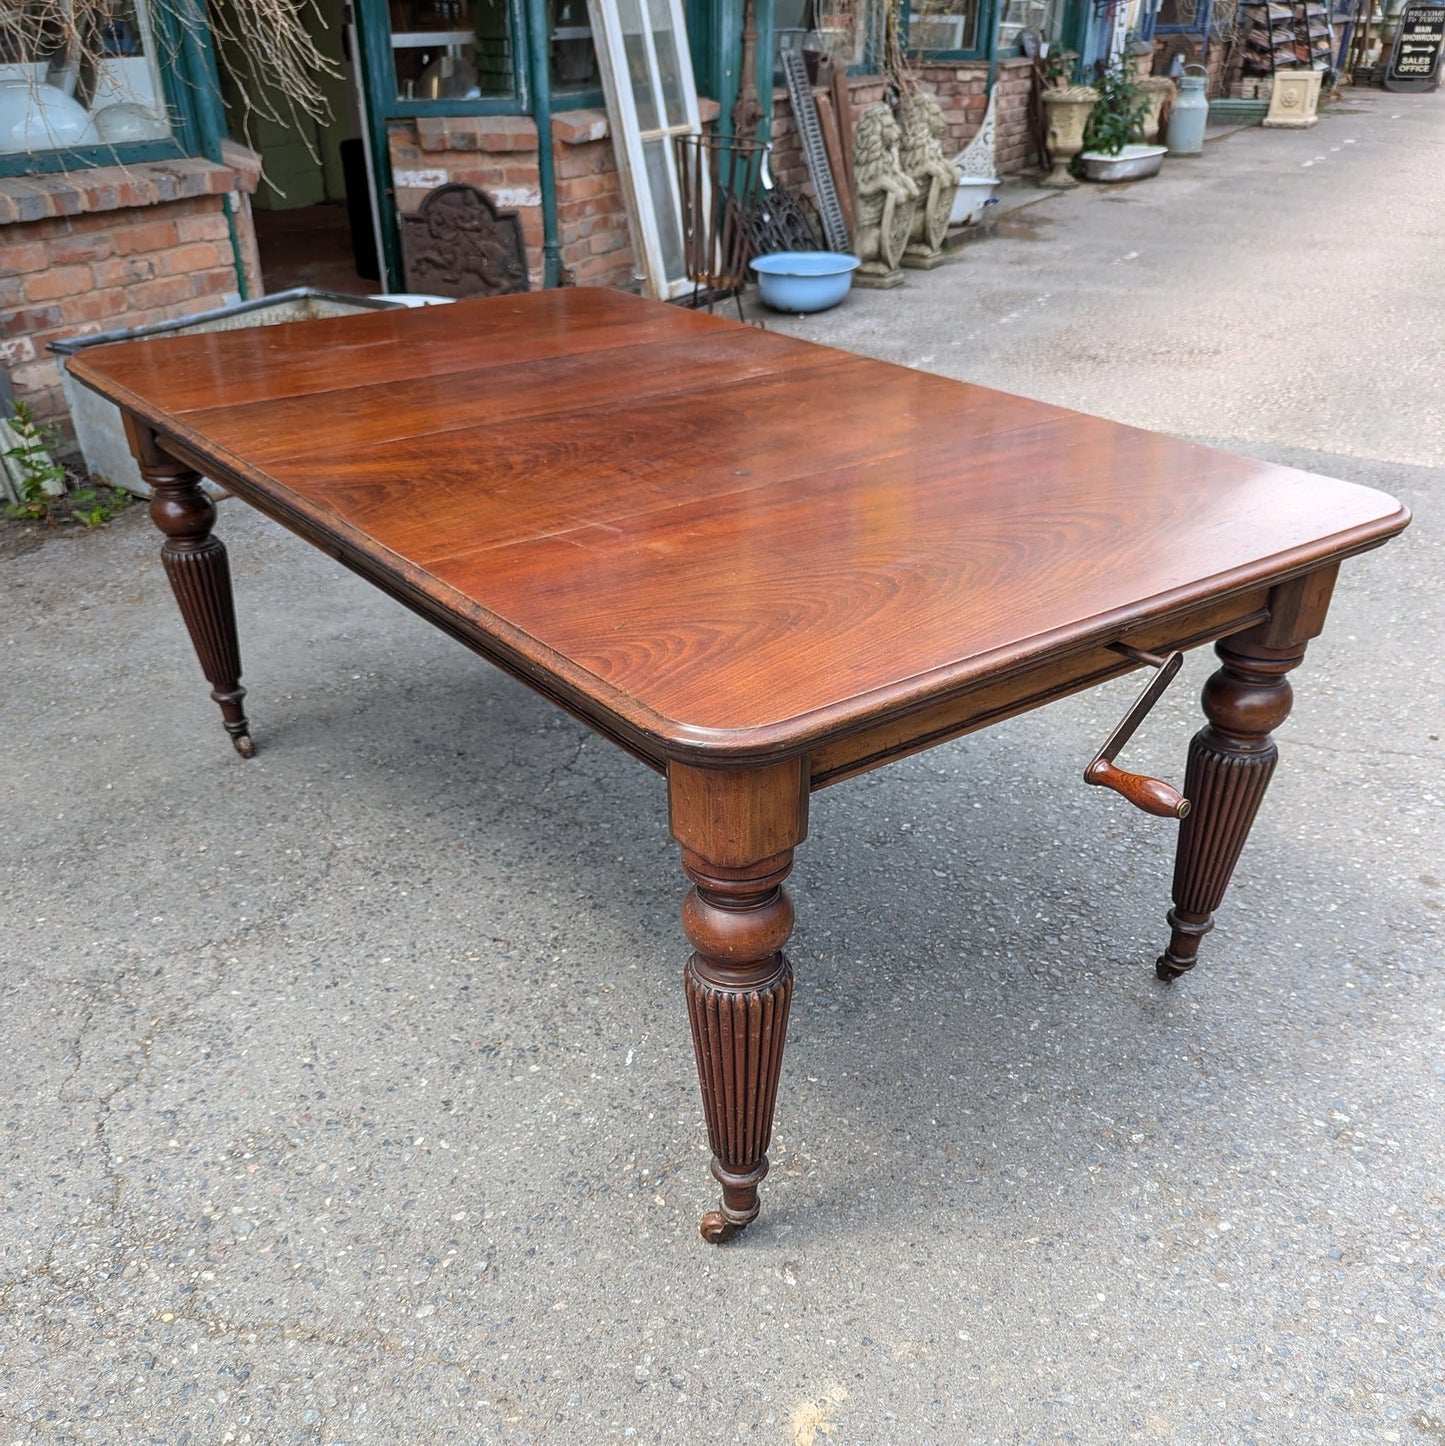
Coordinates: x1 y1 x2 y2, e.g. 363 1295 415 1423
130 425 255 758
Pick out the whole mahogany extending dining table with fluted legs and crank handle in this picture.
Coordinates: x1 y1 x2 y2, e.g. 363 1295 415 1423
69 289 1409 1241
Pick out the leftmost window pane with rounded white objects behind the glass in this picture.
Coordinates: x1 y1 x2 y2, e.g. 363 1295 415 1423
0 0 171 155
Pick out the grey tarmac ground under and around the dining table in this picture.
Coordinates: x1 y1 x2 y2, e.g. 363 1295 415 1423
0 93 1445 1446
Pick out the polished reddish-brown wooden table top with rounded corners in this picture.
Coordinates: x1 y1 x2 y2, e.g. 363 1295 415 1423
69 289 1409 758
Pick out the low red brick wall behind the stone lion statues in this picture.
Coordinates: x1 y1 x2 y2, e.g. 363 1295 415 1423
771 56 1037 215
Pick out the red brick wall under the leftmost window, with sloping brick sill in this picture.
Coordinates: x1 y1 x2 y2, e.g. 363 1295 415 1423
0 152 255 435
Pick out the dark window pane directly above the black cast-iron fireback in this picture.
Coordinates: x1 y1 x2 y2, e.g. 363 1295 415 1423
391 0 515 100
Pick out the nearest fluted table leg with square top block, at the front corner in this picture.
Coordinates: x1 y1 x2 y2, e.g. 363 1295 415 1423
668 759 807 1244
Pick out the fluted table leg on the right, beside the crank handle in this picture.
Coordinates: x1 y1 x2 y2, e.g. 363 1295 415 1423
1154 568 1335 980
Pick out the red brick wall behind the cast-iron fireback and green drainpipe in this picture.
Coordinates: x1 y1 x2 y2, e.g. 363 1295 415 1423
388 110 634 286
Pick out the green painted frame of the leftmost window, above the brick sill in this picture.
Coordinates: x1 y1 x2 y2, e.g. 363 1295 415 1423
0 0 226 176
